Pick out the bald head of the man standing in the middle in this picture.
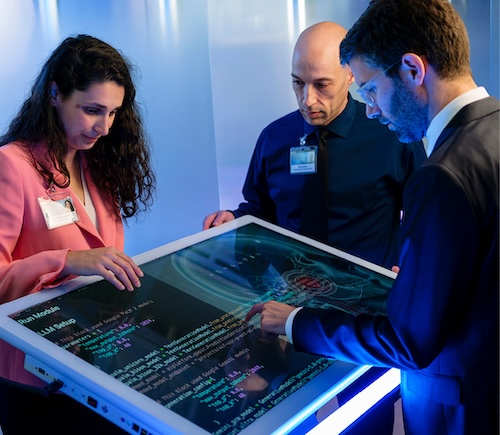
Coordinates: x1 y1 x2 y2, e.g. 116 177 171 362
292 21 354 126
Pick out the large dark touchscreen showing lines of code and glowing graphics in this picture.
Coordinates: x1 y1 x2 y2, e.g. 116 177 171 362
13 223 392 434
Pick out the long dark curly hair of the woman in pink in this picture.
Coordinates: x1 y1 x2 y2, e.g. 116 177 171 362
0 35 155 218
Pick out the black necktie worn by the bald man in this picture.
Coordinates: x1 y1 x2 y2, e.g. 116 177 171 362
301 128 328 243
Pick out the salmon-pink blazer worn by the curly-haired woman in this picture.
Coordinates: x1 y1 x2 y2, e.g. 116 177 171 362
0 143 124 385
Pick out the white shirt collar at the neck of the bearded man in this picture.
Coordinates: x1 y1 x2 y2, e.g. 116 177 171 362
426 86 489 156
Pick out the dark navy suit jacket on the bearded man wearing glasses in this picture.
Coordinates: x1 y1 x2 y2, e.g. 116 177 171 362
293 98 499 435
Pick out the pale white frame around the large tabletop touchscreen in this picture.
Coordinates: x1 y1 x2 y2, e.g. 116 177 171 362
0 216 396 434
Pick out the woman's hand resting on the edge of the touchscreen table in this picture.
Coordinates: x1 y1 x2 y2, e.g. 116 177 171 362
62 247 144 291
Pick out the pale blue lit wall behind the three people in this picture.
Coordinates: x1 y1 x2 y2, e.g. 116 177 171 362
0 0 499 255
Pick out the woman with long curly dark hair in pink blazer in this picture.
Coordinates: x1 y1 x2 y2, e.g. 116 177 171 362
0 35 154 302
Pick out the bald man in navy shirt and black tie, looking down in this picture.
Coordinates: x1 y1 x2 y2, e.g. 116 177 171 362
203 22 425 268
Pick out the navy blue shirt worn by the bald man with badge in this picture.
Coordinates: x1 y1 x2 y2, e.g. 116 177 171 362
233 96 426 268
